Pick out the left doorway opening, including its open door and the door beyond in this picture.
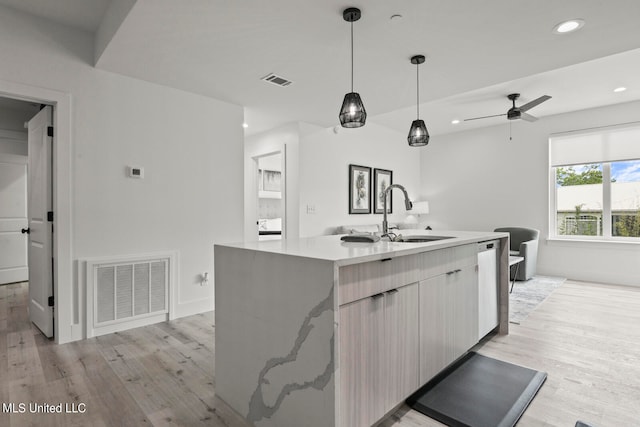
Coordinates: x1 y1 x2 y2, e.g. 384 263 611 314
0 97 54 338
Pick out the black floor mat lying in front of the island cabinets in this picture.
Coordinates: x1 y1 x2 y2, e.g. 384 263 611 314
407 352 547 427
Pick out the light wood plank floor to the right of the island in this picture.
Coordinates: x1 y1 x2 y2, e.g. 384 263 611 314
381 281 640 427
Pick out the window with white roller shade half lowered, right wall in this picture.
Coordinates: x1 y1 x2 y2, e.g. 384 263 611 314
549 124 640 241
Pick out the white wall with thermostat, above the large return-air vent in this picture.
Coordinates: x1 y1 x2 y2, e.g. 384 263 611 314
0 7 243 340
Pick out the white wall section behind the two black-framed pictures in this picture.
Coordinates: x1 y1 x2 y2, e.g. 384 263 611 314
299 122 426 237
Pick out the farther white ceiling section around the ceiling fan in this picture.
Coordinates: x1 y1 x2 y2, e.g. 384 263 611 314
375 49 640 135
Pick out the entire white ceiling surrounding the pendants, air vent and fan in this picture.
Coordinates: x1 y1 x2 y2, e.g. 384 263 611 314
0 0 640 135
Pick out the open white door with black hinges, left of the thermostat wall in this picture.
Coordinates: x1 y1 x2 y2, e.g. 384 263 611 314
28 106 53 337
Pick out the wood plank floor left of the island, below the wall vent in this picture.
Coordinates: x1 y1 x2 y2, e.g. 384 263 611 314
0 283 247 427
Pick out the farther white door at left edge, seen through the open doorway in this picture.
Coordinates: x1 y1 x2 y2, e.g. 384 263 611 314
0 152 29 285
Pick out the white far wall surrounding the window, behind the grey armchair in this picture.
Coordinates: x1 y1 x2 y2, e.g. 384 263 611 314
421 102 640 286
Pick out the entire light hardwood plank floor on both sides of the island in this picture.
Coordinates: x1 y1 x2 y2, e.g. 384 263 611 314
0 281 640 427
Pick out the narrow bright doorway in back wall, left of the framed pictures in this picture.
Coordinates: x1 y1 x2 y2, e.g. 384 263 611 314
253 151 286 241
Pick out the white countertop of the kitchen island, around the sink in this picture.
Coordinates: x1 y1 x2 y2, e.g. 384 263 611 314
215 229 509 265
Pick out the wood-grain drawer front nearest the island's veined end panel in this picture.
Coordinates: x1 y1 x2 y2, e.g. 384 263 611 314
338 254 422 305
